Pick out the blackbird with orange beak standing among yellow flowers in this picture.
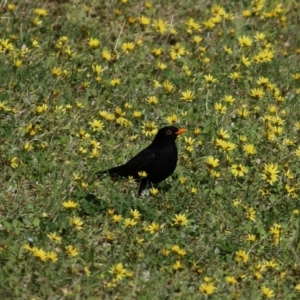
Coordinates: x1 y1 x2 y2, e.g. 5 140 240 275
97 126 187 194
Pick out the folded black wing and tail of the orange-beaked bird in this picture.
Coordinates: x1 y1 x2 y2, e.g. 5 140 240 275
97 148 156 178
